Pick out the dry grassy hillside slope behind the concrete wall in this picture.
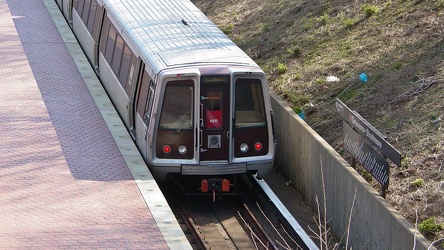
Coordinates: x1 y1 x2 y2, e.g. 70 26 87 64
193 0 444 248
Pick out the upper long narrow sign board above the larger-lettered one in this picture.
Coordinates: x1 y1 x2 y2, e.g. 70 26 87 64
336 99 401 167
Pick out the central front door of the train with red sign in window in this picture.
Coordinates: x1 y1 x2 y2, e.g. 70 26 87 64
199 76 230 161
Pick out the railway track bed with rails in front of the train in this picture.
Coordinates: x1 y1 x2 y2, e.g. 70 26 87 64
162 177 317 250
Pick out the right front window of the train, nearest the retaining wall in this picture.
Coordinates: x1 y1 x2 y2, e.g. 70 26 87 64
235 79 266 128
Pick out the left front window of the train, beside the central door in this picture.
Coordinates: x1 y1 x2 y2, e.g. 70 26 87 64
159 80 193 133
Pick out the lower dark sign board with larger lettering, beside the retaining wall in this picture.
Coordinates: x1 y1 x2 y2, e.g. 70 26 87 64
342 122 390 189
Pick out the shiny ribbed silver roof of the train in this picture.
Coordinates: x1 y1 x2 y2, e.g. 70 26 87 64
103 0 257 71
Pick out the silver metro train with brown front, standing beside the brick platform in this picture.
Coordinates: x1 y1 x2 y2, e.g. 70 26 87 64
55 0 275 193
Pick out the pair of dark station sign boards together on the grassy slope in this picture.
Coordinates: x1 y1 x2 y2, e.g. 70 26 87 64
336 99 401 198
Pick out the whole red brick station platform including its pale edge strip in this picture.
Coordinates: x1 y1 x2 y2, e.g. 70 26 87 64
0 0 191 249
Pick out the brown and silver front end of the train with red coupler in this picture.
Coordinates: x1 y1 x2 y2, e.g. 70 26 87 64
147 67 275 194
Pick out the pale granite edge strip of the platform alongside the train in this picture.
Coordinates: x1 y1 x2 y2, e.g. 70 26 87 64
43 0 192 249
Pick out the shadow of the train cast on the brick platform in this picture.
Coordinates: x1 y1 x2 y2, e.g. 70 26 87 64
10 3 134 181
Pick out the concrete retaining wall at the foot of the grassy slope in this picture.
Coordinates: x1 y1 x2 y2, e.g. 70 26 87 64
271 93 430 250
